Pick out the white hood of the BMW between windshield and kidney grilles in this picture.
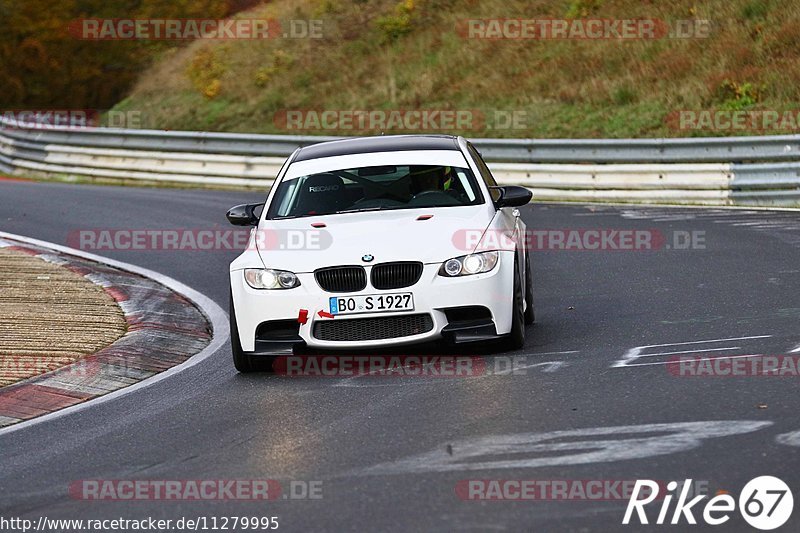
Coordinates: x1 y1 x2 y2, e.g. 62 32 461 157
256 205 493 273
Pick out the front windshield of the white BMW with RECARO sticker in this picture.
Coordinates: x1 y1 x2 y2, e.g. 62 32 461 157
267 165 483 219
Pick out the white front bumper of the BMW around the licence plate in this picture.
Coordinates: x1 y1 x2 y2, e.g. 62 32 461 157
230 252 514 353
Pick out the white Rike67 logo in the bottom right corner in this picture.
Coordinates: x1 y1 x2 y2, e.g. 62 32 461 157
622 476 794 530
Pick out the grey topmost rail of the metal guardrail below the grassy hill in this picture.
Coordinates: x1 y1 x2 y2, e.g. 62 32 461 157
0 118 800 163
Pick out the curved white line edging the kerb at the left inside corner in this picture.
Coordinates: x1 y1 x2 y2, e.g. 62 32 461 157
0 231 230 435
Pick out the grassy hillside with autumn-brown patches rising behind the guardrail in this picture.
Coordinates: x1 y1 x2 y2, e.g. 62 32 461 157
111 0 800 138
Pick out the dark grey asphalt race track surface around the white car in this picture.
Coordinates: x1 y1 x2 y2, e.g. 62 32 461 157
0 181 800 531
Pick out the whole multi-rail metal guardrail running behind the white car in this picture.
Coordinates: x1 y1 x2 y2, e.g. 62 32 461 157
0 118 800 205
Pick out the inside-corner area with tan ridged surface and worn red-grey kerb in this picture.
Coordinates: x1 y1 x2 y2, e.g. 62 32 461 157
0 238 212 427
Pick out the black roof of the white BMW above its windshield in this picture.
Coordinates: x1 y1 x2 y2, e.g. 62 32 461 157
294 135 459 161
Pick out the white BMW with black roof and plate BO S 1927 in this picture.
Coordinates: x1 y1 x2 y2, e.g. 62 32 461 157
227 135 534 372
